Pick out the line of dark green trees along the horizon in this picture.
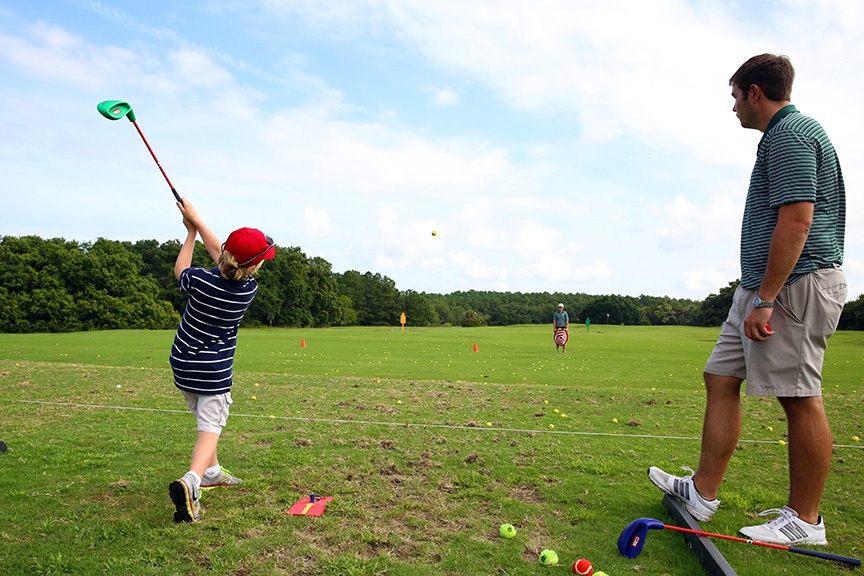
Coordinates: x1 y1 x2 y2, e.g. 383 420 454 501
0 236 864 333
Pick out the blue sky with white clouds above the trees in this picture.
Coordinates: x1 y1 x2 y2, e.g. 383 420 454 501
0 0 864 299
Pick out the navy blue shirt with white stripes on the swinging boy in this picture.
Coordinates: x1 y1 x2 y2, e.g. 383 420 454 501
171 266 258 395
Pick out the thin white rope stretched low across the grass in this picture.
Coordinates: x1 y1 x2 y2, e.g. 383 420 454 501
12 400 864 448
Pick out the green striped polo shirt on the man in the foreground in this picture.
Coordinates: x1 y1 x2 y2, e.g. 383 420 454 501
741 105 846 290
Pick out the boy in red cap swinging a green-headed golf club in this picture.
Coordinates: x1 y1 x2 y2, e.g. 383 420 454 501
168 200 276 522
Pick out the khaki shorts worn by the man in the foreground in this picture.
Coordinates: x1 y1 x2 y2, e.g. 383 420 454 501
705 268 846 397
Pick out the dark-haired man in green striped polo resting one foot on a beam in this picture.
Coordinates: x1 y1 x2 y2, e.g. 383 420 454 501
648 54 846 546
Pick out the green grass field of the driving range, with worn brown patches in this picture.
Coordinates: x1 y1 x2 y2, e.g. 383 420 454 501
0 326 864 576
